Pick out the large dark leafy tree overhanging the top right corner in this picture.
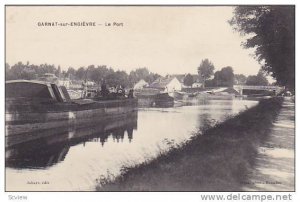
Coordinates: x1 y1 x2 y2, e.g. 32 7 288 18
229 6 295 90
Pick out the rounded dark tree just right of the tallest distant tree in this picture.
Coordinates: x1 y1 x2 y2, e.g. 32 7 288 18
213 66 234 87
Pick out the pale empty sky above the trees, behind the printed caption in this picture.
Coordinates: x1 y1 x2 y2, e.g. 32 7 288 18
6 6 260 75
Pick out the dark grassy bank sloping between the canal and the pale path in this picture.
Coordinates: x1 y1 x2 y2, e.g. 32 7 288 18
97 98 282 191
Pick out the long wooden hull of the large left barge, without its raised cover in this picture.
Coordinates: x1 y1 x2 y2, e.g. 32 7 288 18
5 99 137 146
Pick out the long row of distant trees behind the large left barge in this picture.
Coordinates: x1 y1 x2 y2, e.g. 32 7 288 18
5 62 160 87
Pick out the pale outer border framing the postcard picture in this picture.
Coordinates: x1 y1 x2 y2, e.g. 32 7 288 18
0 0 300 202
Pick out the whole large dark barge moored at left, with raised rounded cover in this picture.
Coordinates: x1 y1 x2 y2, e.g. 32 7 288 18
5 80 137 147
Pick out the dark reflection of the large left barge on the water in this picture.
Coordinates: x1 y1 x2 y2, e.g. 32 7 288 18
6 112 137 169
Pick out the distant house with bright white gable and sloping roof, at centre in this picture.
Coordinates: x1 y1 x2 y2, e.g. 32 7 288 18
149 76 182 93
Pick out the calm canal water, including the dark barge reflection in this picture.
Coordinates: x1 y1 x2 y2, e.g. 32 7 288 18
6 99 258 191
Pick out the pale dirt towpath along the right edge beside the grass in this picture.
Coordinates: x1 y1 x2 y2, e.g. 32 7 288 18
244 98 295 191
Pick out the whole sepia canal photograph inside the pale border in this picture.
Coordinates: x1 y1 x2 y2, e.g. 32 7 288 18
3 4 296 192
